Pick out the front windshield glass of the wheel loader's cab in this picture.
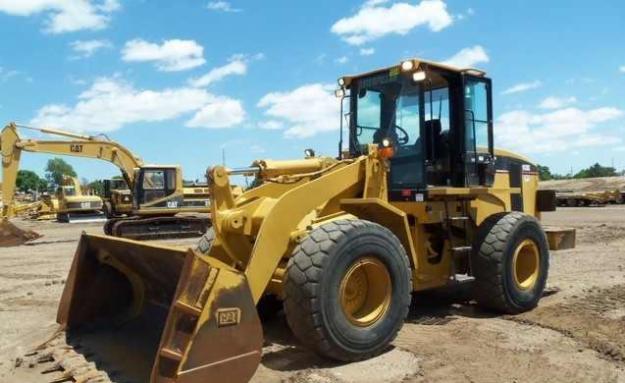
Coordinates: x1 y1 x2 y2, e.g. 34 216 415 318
351 72 423 188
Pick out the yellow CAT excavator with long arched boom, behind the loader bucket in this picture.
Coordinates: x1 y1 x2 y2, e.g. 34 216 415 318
0 123 210 239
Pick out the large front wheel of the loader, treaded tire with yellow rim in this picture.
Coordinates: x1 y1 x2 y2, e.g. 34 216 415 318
284 220 412 361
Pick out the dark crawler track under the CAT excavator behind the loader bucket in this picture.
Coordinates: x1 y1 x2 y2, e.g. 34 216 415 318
104 216 211 240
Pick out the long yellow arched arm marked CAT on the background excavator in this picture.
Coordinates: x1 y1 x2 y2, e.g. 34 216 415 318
0 123 143 218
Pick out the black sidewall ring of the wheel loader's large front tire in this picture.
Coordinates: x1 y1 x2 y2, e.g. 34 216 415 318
319 226 412 355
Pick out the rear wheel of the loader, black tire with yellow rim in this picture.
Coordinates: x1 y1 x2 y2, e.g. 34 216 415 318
471 212 549 314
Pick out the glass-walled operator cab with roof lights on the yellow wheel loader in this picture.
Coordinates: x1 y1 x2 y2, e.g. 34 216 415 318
339 60 495 201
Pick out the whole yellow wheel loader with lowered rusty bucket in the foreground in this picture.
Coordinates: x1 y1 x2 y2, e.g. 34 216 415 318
30 60 573 383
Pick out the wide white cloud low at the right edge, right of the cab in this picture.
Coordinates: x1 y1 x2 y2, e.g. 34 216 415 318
495 107 625 153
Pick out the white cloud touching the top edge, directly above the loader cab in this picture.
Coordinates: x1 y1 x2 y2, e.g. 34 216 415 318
331 0 453 45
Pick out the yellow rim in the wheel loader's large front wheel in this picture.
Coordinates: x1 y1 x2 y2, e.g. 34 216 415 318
339 257 392 327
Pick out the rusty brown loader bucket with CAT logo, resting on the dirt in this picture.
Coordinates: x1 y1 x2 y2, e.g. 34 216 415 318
57 234 263 383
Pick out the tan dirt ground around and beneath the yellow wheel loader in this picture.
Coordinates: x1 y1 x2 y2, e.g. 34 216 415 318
0 206 625 383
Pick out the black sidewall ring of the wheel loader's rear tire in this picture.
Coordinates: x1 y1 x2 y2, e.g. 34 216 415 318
503 217 549 310
